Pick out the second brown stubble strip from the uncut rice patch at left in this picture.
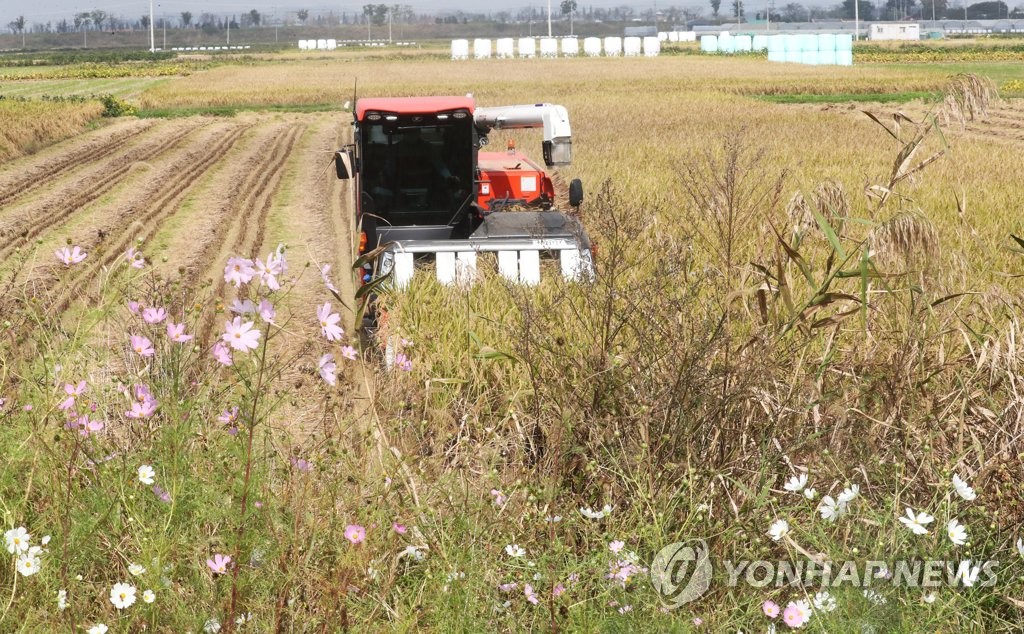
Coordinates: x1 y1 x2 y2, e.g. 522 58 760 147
0 122 202 258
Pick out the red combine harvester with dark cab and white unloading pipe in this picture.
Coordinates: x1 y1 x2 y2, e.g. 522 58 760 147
336 96 593 329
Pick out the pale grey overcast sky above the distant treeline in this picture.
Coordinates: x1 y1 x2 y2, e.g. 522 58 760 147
6 0 840 28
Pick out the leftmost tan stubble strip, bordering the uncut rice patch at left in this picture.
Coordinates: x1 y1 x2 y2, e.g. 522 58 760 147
0 121 154 209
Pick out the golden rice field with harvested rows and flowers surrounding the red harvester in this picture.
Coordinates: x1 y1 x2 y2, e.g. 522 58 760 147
0 47 1024 632
